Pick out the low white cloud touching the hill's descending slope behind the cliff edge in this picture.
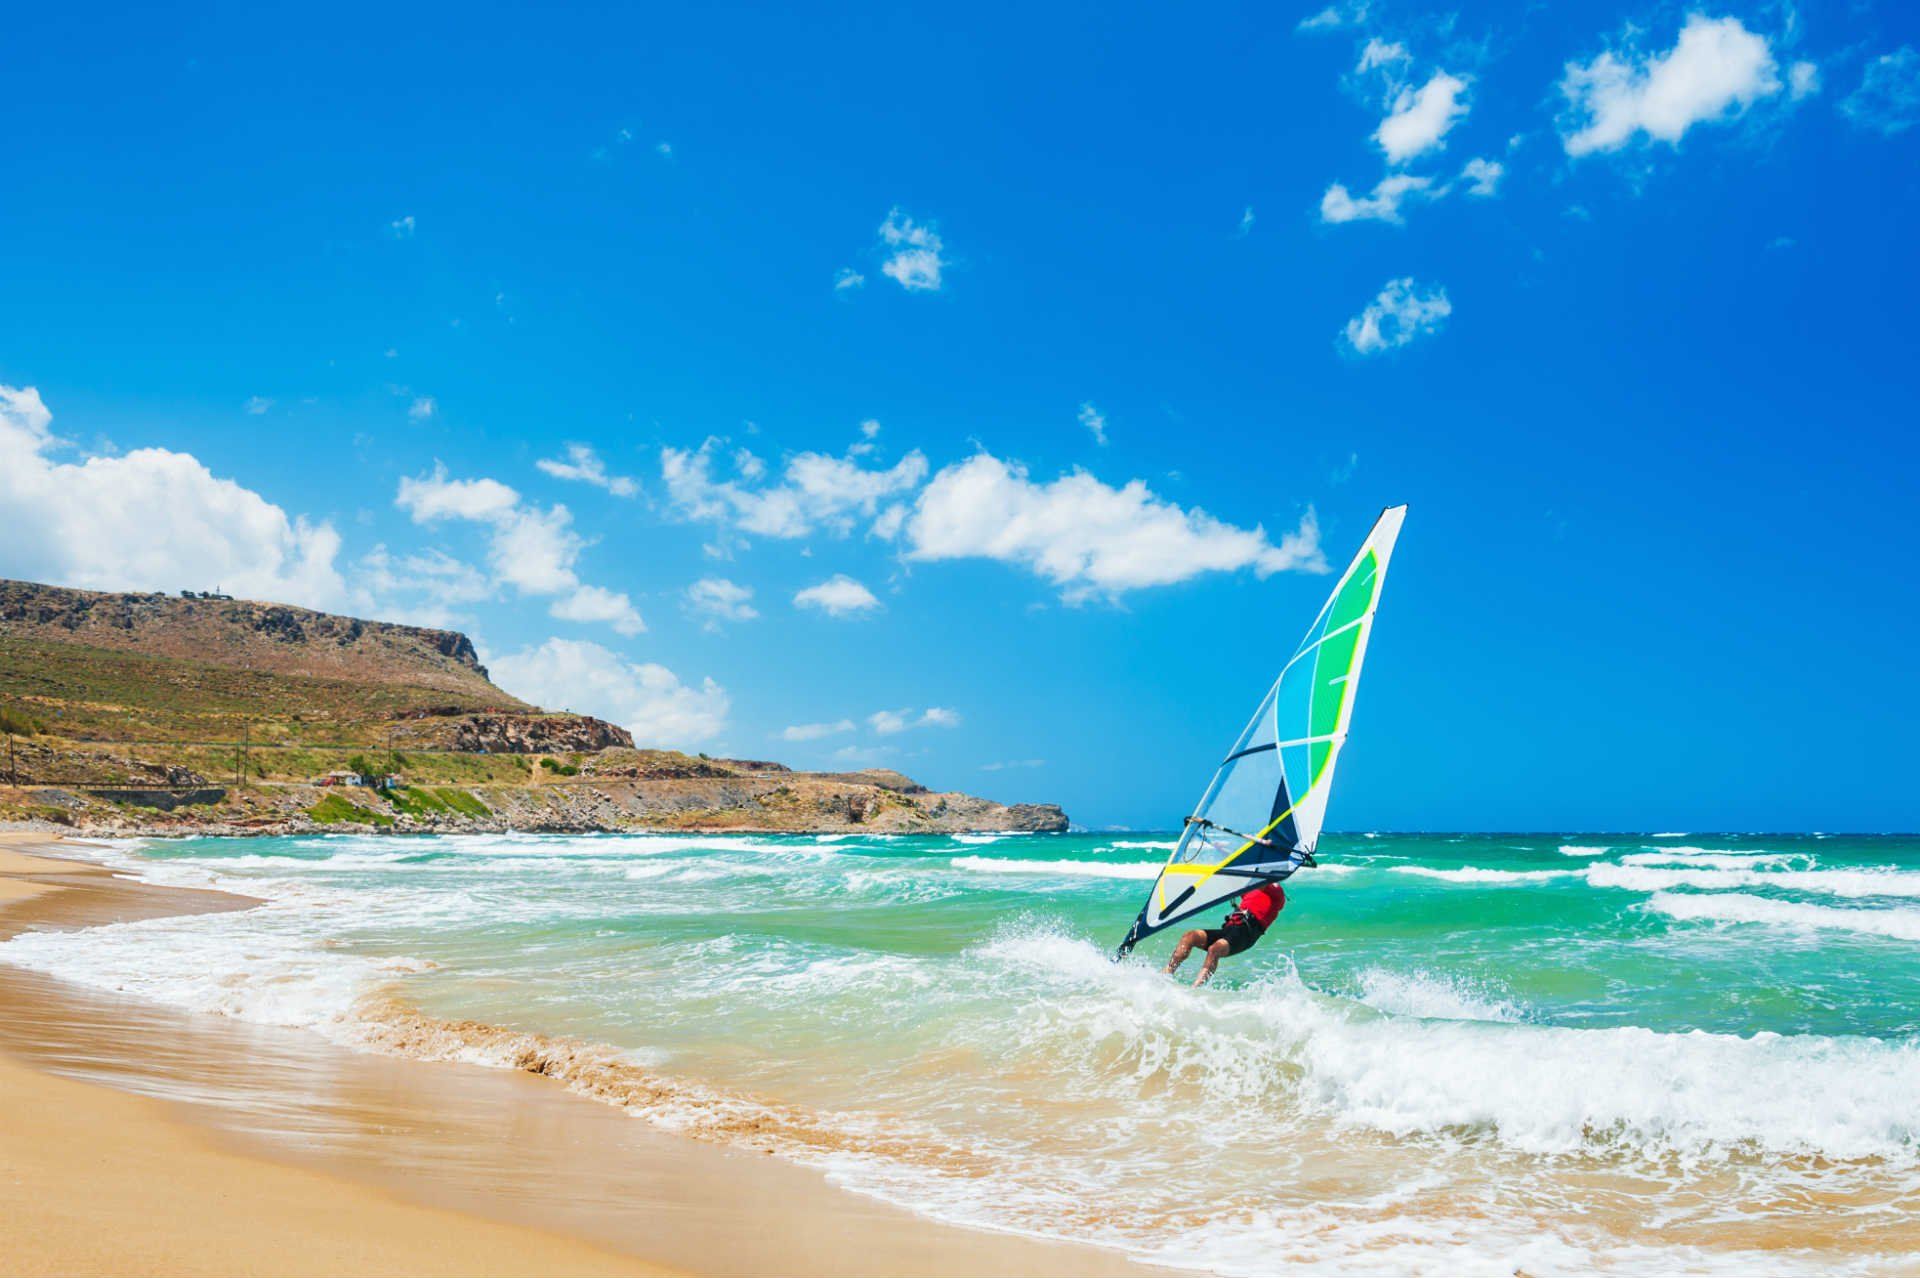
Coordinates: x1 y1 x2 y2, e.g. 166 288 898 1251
490 639 730 748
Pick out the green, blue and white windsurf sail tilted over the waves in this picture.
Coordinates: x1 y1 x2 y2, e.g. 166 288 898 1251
1119 507 1407 954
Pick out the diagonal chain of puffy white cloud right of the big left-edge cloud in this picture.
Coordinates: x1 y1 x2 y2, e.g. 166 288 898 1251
394 464 647 635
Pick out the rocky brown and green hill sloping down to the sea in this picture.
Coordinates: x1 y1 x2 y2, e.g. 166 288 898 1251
0 580 1066 833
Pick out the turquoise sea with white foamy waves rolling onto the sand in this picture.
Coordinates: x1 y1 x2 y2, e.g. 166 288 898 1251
0 831 1920 1274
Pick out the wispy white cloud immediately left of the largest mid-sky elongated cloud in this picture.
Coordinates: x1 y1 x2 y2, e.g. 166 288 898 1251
660 439 927 539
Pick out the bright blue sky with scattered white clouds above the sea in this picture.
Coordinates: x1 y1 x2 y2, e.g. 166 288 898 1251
0 2 1920 829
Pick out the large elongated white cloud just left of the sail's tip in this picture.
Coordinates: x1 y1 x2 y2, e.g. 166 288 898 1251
906 453 1327 601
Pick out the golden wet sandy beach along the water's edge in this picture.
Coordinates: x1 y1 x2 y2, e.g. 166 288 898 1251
0 833 1156 1276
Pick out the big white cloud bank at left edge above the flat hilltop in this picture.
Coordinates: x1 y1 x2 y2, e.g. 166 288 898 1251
0 386 348 608
